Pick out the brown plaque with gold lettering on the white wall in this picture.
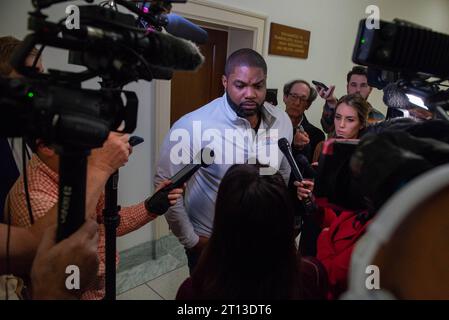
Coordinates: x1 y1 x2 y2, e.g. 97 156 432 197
268 22 310 59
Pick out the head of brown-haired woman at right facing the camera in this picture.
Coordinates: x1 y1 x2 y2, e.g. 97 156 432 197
334 94 370 139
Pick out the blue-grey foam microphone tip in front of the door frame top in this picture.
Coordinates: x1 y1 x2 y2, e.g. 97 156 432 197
165 13 208 44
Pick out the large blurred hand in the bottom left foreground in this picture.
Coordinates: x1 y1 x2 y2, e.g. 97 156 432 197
31 220 98 299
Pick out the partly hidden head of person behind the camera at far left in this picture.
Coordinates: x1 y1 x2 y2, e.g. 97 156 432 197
0 36 44 78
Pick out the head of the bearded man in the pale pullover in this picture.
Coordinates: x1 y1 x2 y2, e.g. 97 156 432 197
222 48 267 118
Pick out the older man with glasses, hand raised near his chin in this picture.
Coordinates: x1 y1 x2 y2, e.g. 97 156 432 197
283 79 325 162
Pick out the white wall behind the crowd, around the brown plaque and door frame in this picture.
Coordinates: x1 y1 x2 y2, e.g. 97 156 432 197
0 0 449 250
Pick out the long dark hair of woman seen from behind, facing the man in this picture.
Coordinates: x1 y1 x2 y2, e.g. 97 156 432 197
192 164 299 299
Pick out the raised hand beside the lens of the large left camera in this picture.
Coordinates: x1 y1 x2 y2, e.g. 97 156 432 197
89 132 132 175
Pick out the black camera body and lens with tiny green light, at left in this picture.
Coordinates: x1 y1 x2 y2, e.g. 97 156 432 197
0 78 138 149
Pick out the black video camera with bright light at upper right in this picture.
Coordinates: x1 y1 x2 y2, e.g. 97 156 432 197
352 19 449 121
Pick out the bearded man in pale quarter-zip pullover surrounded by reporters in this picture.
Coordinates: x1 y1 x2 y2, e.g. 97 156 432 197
154 49 293 271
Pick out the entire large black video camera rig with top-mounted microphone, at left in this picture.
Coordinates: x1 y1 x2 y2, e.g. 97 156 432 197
0 0 207 240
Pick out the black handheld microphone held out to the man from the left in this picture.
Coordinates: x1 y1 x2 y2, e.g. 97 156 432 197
145 148 215 215
